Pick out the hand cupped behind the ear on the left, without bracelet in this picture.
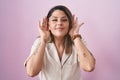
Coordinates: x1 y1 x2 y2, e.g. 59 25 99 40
38 17 50 42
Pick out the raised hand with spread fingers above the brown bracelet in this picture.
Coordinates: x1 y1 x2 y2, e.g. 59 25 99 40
69 15 84 37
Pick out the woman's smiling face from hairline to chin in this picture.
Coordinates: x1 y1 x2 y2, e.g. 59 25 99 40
48 10 69 37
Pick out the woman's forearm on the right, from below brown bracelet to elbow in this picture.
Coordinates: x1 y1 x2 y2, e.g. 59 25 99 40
74 37 95 71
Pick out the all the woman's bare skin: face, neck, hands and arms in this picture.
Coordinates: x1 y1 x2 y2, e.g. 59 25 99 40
26 10 95 77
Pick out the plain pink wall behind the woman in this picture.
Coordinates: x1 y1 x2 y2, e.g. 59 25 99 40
0 0 120 80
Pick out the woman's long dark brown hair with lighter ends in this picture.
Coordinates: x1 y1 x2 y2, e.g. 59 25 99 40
47 5 73 54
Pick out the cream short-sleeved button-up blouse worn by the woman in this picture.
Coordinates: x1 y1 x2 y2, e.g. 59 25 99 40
25 38 82 80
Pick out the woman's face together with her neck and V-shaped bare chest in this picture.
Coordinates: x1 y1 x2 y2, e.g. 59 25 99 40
48 10 69 60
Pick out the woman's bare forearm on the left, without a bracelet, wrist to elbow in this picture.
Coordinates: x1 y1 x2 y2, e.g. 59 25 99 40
26 41 46 76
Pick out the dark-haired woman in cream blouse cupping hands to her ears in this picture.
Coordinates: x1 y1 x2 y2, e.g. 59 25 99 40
25 5 95 80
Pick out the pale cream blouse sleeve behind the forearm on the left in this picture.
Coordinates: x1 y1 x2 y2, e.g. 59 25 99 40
24 38 40 66
